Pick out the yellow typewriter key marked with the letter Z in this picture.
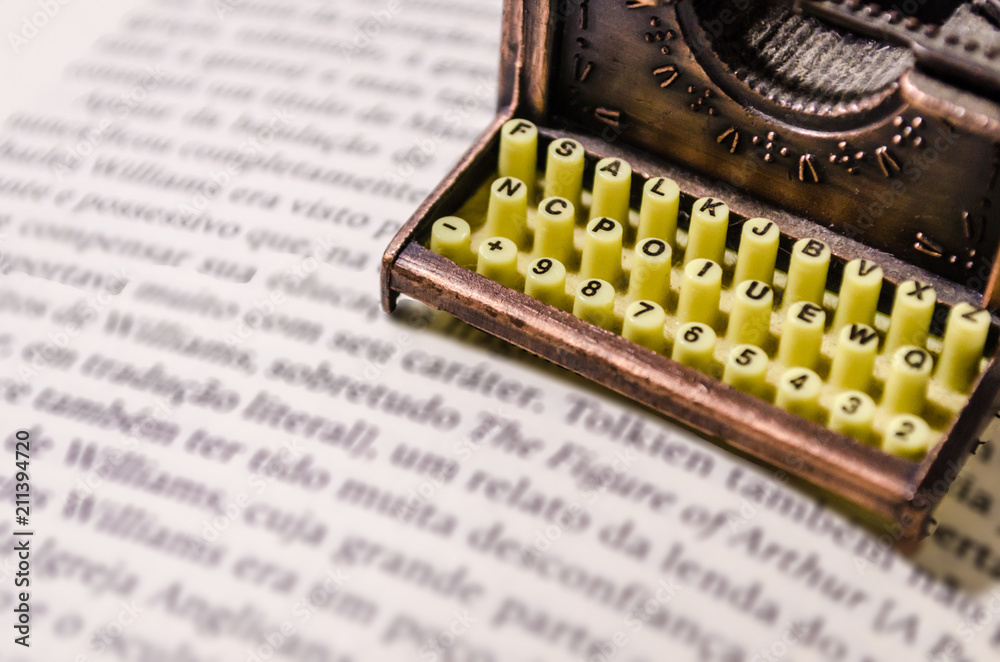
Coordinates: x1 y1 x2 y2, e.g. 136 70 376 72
936 303 990 393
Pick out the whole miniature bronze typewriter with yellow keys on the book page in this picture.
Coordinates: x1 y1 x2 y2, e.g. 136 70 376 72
382 0 1000 541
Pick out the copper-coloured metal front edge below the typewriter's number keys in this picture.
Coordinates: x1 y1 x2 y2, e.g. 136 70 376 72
390 243 928 537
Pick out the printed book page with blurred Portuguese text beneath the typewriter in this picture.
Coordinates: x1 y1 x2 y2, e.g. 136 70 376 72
0 0 1000 662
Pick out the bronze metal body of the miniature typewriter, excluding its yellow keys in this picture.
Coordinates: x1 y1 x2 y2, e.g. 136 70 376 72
382 0 1000 541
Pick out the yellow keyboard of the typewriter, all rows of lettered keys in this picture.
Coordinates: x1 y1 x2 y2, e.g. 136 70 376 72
426 119 991 460
